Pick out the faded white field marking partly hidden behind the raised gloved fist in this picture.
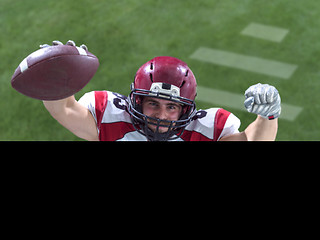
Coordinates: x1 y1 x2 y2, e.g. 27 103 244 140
196 86 303 121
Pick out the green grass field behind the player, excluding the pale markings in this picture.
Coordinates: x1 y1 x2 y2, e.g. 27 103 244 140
0 0 320 140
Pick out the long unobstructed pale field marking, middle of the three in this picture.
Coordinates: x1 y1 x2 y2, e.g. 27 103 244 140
190 47 298 79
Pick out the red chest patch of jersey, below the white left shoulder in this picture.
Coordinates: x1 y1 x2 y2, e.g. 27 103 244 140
99 122 136 141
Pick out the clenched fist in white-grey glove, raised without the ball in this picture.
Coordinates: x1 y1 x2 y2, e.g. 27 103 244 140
244 83 281 120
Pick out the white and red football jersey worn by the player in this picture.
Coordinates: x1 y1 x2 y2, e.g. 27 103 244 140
79 91 240 141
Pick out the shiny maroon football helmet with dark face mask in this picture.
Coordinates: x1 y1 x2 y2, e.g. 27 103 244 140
128 57 197 141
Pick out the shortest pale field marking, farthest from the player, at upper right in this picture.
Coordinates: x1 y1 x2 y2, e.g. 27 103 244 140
241 23 289 42
